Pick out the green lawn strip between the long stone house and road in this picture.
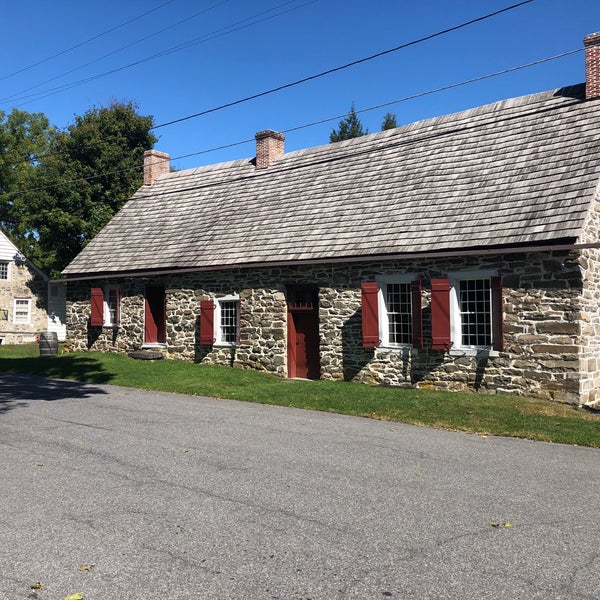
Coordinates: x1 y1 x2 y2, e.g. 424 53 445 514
0 345 600 448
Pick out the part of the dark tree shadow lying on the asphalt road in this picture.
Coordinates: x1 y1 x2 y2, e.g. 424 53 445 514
0 373 108 414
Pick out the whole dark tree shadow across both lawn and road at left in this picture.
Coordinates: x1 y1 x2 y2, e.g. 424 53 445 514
0 356 114 414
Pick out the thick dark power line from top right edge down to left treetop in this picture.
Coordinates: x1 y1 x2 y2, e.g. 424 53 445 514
152 0 534 129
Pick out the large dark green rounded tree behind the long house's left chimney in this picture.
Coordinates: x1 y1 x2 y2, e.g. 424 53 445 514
24 102 157 275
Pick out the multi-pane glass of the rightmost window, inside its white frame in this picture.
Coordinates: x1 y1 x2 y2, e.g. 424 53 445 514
458 279 492 346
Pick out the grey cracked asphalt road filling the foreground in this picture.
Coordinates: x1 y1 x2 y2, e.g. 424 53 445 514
0 374 600 600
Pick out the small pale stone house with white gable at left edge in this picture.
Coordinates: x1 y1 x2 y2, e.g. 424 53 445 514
0 231 48 344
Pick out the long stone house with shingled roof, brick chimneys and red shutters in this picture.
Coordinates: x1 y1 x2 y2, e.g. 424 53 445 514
64 34 600 404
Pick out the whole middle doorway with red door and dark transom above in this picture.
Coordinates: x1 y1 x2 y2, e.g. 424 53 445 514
287 285 321 379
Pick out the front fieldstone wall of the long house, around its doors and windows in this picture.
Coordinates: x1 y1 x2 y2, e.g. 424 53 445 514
68 252 584 402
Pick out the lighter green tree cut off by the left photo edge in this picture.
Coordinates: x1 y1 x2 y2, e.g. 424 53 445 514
0 108 57 247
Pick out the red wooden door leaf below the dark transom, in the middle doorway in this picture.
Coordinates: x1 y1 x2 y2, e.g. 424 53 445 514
288 312 321 379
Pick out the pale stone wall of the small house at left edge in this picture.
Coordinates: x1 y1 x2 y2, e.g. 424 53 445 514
0 261 48 344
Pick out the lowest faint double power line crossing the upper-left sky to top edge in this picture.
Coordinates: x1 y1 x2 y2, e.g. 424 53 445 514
2 0 318 105
